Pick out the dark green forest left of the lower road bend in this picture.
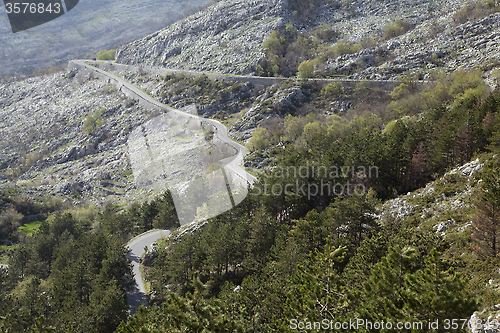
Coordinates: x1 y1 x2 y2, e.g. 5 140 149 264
0 192 179 333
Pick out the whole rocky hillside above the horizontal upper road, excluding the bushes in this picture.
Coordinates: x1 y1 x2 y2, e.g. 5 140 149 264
116 0 499 83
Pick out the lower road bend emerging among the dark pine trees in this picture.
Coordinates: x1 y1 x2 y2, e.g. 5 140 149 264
126 230 170 315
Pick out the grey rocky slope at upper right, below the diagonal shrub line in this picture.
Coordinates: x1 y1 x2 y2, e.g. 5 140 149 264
342 13 500 84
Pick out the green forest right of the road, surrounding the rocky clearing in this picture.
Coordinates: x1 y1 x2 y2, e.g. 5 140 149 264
113 72 500 332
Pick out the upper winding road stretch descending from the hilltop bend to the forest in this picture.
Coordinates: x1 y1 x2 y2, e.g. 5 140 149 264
71 60 257 185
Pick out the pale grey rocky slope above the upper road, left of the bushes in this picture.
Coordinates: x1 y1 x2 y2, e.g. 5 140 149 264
116 0 288 73
